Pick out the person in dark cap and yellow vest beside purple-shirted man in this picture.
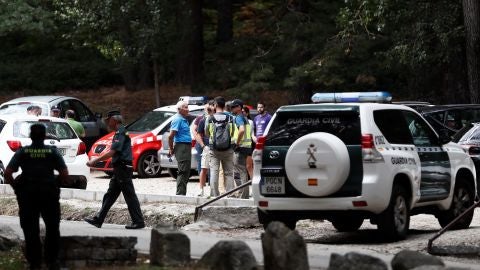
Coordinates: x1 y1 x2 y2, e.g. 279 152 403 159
232 99 252 199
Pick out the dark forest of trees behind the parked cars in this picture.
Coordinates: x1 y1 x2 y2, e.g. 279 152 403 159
0 0 480 120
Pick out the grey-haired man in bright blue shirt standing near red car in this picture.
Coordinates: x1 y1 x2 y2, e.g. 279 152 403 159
168 101 192 195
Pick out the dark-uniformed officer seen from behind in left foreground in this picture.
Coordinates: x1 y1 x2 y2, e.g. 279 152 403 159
5 124 68 269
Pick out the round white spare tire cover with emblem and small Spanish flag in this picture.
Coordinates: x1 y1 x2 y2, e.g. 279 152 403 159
285 132 350 196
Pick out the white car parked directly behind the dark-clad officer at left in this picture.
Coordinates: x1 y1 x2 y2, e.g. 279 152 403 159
0 114 90 189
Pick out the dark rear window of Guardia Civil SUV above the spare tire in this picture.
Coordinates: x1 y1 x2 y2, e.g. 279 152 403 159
265 110 361 145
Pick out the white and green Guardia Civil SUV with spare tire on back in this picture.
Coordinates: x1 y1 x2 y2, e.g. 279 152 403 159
252 92 477 240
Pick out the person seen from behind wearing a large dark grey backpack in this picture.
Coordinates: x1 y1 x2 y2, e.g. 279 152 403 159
205 97 234 197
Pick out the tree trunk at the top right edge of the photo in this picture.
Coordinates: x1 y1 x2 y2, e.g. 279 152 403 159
462 0 480 103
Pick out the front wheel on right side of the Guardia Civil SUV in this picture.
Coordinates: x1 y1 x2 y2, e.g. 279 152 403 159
437 180 475 230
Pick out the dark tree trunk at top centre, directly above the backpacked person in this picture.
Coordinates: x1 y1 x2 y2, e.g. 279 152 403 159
217 0 233 43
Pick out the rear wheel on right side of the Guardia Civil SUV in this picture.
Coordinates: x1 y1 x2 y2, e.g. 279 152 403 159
377 185 410 241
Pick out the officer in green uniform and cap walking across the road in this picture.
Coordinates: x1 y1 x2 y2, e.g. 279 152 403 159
84 110 145 229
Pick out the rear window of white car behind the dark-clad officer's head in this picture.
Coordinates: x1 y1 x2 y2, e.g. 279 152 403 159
13 121 78 140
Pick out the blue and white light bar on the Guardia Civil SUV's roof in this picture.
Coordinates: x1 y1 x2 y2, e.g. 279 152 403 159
312 91 392 103
